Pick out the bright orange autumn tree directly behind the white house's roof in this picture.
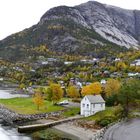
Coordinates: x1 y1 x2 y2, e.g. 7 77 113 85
81 82 102 96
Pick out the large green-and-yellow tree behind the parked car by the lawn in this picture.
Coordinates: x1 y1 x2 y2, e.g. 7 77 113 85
47 83 63 104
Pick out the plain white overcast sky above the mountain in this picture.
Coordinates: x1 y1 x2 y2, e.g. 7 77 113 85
0 0 140 39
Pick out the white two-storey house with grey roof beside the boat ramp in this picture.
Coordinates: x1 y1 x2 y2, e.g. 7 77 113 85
81 95 105 117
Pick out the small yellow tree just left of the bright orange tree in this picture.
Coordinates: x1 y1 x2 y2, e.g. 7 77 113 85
67 86 80 98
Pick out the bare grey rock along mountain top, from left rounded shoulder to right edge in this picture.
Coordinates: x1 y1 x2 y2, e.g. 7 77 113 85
40 1 140 48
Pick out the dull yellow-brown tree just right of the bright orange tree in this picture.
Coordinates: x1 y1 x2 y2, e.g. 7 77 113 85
105 79 121 96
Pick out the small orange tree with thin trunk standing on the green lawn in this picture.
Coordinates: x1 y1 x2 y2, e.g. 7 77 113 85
33 92 44 110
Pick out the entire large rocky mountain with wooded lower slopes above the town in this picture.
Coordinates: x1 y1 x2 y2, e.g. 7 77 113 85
0 1 140 59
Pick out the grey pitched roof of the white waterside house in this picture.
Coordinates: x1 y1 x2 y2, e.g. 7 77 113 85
86 95 105 103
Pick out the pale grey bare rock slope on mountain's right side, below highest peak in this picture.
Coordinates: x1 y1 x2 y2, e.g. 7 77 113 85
77 1 140 48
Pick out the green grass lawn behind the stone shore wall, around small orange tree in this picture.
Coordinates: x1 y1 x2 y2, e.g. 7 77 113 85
0 98 64 114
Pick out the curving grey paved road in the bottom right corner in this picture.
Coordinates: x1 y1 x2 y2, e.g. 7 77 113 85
103 119 140 140
